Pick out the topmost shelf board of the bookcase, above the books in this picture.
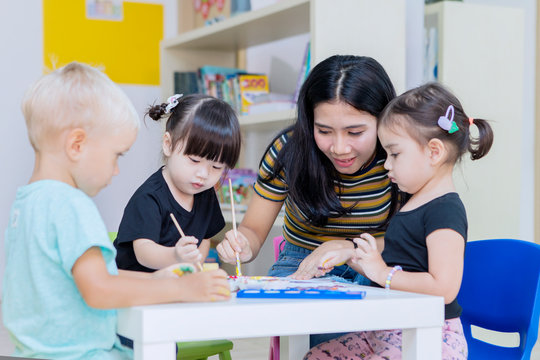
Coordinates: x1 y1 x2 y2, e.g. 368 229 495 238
162 0 310 51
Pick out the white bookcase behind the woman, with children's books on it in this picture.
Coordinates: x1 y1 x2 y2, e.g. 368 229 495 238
161 0 406 129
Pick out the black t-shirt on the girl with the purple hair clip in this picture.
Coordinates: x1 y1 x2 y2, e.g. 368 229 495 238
382 193 468 319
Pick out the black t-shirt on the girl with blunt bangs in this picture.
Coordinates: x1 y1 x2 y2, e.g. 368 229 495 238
114 168 225 272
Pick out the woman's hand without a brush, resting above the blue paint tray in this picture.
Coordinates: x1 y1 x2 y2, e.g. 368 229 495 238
291 240 353 280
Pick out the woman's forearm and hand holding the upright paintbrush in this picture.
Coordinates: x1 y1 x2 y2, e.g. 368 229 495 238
217 193 283 264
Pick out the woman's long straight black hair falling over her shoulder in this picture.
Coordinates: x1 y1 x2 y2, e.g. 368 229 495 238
261 55 398 226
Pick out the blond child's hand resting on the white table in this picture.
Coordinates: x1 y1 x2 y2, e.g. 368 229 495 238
178 269 231 301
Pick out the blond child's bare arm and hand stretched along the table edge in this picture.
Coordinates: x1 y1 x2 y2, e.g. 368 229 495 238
72 247 230 309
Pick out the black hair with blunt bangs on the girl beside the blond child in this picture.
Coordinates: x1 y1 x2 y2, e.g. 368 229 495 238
146 94 242 169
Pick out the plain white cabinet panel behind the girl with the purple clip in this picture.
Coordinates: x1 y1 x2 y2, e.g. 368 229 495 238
425 1 533 240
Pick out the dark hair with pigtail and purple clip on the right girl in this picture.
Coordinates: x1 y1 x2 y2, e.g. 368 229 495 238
379 82 493 164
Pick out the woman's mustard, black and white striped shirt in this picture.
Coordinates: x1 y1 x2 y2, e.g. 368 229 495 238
253 132 391 250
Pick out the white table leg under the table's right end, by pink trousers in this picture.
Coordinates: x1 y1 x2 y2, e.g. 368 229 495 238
402 326 442 360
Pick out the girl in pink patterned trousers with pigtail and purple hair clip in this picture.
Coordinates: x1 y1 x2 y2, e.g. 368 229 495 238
305 83 493 360
